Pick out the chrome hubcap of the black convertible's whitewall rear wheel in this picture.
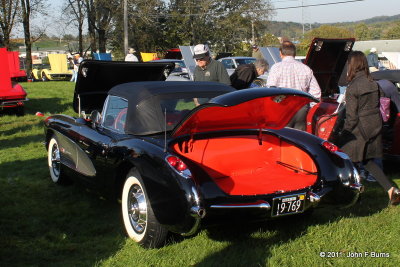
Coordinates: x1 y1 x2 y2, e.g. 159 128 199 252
128 184 147 233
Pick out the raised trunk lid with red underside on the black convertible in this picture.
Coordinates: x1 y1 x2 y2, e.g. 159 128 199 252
172 88 318 137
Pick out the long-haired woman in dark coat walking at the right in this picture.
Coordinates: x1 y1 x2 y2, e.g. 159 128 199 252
341 51 400 205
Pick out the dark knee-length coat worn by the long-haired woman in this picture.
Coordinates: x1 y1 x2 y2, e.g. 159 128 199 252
342 72 382 162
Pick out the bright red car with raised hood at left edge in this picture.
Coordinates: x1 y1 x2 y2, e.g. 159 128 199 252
0 48 28 115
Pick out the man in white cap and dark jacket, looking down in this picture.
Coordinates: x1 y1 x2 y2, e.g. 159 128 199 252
193 44 231 85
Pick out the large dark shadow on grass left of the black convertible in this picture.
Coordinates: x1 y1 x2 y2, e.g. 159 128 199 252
0 157 126 266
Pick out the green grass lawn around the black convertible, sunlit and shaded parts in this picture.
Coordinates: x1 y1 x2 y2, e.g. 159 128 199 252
0 82 400 267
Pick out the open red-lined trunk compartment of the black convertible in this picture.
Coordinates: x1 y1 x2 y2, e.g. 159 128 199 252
173 134 318 195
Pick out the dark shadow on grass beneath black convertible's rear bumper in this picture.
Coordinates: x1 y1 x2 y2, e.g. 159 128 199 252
195 184 387 267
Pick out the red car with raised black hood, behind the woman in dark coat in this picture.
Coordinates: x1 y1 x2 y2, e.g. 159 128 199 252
305 38 400 160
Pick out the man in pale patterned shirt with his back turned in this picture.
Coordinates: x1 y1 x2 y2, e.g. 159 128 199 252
267 41 321 131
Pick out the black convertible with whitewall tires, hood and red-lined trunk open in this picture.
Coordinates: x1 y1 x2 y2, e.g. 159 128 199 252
45 61 362 247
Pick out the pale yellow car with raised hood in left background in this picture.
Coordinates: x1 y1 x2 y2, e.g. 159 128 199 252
32 54 73 82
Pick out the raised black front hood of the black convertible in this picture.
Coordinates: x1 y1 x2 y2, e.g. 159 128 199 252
73 60 174 114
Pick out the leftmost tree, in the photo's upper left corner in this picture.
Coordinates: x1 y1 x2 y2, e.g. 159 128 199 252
0 0 19 48
